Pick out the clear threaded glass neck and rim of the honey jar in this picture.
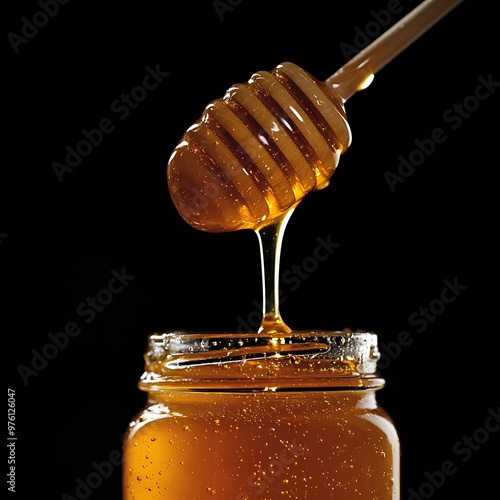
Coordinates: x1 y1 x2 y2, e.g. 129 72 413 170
139 331 384 392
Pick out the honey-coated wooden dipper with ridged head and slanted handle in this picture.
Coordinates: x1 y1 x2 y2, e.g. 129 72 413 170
167 0 462 232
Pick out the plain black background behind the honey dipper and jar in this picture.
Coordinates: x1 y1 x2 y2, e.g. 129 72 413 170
0 0 500 500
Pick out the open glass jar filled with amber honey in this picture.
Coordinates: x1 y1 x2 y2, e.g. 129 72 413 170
123 331 400 500
